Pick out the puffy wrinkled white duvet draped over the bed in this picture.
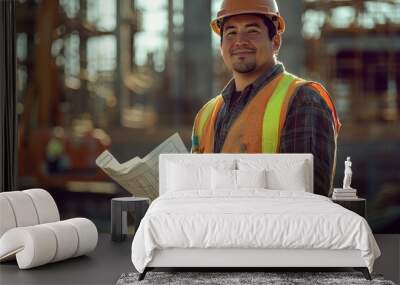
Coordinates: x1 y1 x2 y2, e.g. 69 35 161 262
132 189 380 272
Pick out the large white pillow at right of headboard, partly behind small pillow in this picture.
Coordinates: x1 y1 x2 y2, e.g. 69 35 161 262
238 160 311 192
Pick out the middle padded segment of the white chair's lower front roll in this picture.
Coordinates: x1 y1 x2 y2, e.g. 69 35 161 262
41 221 78 262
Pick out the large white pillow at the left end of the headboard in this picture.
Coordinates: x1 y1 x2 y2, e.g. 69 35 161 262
167 162 211 191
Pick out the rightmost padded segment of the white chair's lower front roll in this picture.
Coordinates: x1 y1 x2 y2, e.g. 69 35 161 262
64 218 98 257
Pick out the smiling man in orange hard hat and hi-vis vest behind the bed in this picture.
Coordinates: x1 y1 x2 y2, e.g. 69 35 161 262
192 0 340 196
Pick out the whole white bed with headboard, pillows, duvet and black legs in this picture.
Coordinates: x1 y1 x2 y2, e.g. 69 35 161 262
132 154 380 279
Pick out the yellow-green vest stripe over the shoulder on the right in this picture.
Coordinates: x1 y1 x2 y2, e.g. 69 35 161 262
262 72 297 153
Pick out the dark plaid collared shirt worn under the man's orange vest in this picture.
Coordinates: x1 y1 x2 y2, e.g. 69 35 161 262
214 63 336 196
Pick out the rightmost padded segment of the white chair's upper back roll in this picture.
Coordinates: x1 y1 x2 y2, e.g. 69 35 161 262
22 188 60 224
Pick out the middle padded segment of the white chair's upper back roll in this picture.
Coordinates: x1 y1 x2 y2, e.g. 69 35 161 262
1 191 39 227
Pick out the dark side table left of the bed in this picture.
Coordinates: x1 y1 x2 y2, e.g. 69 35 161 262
111 197 150 241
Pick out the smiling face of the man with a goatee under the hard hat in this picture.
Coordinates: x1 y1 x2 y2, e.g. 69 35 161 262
221 14 279 74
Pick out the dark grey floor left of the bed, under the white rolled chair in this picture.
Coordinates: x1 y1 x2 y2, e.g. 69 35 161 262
0 234 134 285
